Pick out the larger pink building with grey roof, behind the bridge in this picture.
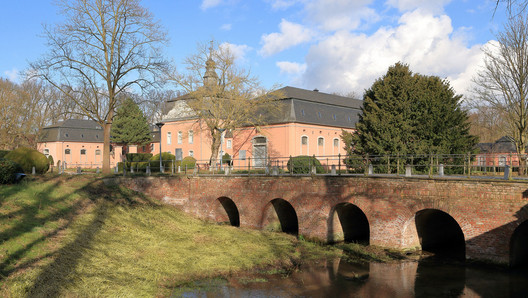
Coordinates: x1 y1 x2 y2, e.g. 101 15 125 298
161 87 363 168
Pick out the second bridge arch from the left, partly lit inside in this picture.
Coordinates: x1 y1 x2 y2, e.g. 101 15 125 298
261 198 299 235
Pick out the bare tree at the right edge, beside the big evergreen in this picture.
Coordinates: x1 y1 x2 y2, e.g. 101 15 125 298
474 14 528 170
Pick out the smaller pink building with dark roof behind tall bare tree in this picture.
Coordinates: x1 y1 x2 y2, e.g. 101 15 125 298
37 119 159 168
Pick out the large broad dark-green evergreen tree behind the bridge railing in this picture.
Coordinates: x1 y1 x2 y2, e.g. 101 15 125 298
342 63 478 155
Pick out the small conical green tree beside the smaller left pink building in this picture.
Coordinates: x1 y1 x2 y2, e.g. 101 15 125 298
110 98 152 149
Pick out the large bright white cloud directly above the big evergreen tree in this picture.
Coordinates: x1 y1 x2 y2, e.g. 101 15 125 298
301 10 482 93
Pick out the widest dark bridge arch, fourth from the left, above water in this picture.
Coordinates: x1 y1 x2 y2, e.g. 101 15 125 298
415 209 466 260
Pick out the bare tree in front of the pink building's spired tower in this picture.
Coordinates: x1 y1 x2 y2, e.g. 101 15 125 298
172 42 281 165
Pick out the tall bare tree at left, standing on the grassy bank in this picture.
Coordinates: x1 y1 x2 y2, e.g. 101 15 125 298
30 0 167 173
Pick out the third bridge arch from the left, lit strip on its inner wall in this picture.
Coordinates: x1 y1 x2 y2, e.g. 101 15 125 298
327 202 370 245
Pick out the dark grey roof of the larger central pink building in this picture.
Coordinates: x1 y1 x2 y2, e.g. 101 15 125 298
162 86 363 128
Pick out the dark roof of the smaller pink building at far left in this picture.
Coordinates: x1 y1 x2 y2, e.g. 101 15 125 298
39 119 160 143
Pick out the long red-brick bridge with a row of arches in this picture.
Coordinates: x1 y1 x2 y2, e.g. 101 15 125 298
116 176 528 266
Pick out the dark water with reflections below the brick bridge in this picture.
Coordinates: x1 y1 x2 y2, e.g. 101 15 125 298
173 260 528 298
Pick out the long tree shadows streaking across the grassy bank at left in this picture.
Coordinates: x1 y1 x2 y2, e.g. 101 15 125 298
0 176 157 297
